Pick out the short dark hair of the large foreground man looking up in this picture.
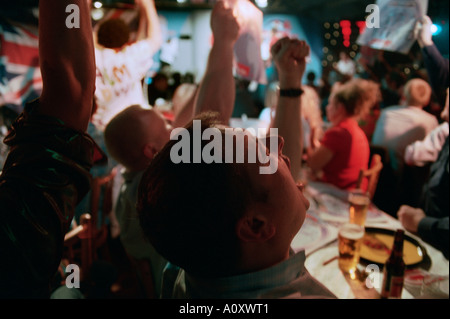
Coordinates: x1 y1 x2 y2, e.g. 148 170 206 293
137 113 266 277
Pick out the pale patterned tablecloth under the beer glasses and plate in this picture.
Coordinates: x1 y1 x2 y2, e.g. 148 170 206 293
292 183 449 299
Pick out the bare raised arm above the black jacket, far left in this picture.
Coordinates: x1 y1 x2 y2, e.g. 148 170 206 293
39 0 95 131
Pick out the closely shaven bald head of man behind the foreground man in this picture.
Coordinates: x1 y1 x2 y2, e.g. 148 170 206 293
105 105 170 170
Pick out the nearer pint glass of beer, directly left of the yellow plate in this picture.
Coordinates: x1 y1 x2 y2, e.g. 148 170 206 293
338 223 364 273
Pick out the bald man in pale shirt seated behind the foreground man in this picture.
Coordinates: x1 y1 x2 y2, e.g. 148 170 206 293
105 105 169 297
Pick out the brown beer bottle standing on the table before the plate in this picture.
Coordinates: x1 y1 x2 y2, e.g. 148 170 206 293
381 229 405 298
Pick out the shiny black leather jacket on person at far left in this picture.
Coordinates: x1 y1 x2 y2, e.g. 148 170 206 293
0 100 99 298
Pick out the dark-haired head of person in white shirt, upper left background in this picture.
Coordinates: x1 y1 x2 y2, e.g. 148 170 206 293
97 18 130 49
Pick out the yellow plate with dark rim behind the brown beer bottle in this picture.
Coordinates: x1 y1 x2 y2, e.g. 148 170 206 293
361 227 426 266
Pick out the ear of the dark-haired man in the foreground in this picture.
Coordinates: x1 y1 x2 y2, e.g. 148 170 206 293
236 214 276 243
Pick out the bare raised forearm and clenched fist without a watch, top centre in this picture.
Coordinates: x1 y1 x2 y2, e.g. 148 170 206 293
195 1 239 125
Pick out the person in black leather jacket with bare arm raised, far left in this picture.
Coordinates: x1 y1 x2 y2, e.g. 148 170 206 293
0 0 95 298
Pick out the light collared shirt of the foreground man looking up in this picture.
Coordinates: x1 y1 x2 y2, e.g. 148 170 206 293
161 251 336 299
